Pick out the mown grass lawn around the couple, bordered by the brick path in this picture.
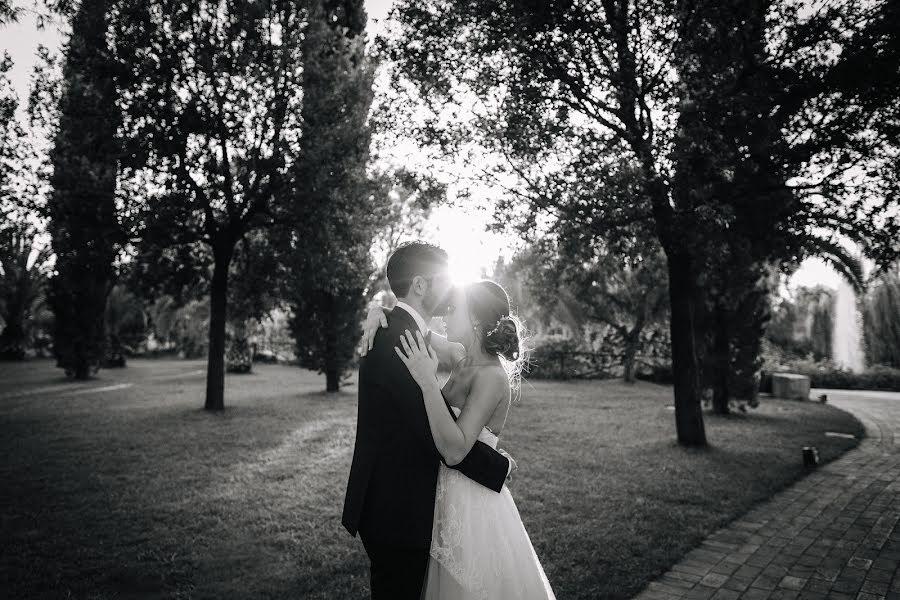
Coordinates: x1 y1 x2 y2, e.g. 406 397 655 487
0 360 863 600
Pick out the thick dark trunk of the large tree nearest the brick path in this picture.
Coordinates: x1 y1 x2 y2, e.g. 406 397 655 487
666 251 706 446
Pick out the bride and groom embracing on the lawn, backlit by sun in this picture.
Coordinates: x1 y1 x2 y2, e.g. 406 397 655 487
342 242 554 600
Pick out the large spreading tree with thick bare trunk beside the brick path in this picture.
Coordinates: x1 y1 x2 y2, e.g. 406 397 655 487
386 0 898 445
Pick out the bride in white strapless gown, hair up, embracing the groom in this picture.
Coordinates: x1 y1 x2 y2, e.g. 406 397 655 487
363 281 555 600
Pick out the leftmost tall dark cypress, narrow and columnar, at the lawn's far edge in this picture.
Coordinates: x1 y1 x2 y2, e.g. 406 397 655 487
47 0 121 379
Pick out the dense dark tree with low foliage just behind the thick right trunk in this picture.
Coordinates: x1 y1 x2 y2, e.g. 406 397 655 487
676 2 897 412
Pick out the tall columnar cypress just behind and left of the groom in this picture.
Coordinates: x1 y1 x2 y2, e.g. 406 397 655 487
286 0 378 392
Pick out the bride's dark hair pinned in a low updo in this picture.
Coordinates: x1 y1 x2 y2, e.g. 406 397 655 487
466 279 525 381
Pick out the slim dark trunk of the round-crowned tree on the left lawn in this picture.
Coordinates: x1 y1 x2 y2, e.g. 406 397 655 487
204 247 233 410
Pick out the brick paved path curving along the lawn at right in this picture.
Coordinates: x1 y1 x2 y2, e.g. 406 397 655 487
636 390 900 600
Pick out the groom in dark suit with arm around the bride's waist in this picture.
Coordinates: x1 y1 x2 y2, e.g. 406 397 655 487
342 242 511 600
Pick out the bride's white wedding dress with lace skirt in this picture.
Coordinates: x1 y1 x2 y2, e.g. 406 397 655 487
422 408 556 600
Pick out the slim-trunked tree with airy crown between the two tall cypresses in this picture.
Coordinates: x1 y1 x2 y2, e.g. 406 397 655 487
116 0 307 410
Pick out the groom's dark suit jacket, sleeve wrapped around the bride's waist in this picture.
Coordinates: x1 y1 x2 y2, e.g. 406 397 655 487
342 308 509 548
